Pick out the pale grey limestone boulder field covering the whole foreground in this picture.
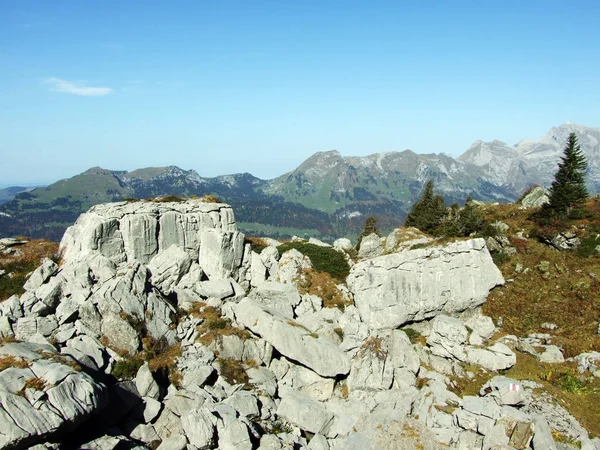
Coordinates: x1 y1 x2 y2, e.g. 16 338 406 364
0 199 600 450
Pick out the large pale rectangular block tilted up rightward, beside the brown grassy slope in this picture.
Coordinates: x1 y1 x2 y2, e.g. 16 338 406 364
348 239 504 329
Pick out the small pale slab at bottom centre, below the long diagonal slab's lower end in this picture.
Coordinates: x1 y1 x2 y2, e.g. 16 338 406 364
277 388 334 434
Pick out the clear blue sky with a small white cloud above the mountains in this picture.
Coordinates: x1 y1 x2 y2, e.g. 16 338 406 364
0 0 600 185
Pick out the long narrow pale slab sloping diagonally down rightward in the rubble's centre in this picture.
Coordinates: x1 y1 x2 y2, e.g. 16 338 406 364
234 298 350 377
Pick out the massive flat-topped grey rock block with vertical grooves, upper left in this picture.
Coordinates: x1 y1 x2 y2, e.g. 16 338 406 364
60 200 244 278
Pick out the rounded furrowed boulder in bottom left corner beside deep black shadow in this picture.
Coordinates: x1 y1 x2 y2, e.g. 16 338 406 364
0 342 107 448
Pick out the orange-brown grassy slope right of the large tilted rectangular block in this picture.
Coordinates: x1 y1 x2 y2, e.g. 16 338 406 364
483 239 600 356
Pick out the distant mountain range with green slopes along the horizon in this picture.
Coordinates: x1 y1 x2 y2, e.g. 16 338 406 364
0 122 600 240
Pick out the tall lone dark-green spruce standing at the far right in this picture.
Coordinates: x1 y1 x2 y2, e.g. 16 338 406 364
543 133 588 219
